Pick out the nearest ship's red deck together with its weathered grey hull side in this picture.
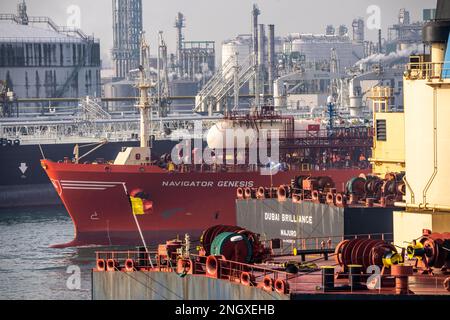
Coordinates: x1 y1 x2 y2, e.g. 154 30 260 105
93 249 450 300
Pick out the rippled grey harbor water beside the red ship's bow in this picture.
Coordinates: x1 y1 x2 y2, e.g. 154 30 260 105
0 206 98 300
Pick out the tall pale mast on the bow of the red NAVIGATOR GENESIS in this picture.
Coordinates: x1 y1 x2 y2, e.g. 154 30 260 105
137 33 151 155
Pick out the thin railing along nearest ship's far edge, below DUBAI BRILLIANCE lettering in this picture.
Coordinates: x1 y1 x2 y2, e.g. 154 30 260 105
261 233 394 255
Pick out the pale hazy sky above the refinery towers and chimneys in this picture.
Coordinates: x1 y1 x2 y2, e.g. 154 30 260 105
0 0 436 67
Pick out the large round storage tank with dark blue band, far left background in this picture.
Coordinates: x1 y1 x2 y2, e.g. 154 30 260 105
0 22 101 105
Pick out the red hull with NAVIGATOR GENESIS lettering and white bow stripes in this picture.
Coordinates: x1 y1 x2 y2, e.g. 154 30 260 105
42 160 369 247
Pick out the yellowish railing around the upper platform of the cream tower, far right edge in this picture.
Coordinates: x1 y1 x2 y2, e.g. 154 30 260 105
405 62 450 81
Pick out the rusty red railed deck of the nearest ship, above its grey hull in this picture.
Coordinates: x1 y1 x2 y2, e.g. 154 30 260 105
94 251 450 296
